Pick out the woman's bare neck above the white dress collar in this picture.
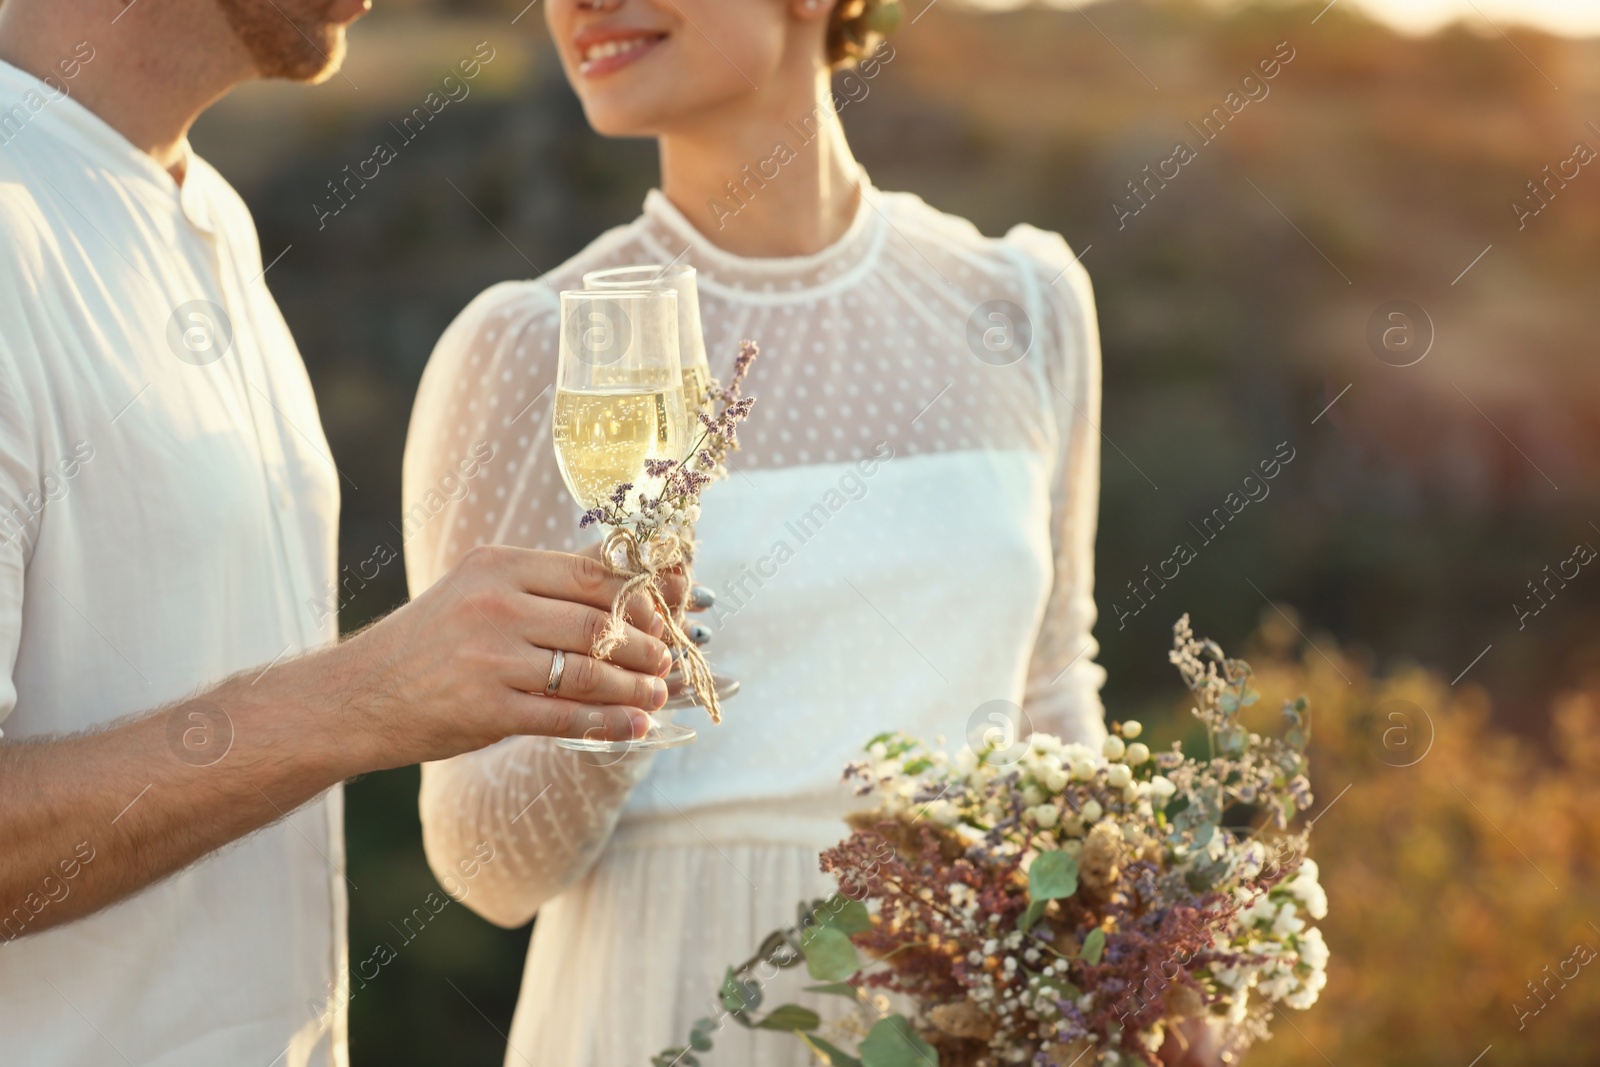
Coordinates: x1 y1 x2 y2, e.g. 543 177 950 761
661 68 862 258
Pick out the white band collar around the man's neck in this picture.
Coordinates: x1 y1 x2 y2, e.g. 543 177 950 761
0 59 216 234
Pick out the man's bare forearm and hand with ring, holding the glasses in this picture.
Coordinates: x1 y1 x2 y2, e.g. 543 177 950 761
0 547 682 939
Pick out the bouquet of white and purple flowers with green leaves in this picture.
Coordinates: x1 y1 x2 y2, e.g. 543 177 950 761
656 616 1328 1067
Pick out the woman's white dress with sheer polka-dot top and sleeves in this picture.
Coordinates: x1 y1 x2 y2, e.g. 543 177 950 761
405 184 1104 1067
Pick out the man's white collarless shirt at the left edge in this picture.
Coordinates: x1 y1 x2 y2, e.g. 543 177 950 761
0 62 347 1067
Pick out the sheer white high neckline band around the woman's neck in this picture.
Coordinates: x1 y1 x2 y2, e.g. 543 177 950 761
640 173 886 302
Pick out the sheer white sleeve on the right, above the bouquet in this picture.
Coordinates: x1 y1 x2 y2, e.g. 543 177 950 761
1006 226 1106 747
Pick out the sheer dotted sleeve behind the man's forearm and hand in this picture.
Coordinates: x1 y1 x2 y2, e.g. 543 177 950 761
402 283 651 926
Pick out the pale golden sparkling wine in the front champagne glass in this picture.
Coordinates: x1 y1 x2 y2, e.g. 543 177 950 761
552 388 688 509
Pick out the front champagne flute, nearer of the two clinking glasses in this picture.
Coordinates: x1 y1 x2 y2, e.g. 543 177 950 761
550 290 694 752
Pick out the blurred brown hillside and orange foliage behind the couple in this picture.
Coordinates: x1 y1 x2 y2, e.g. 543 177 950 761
181 0 1600 1067
